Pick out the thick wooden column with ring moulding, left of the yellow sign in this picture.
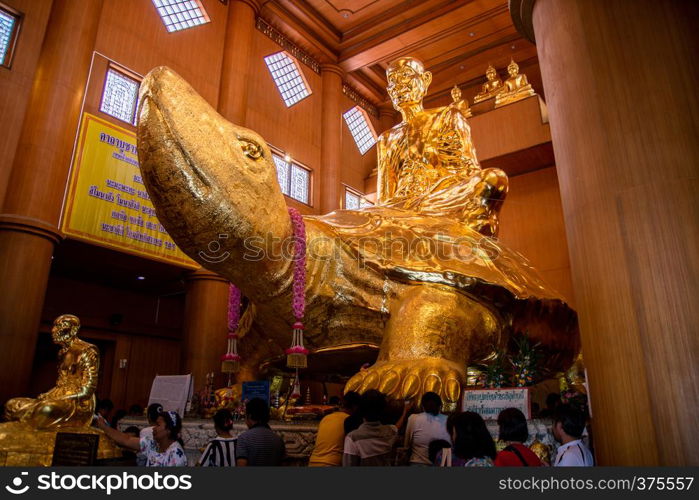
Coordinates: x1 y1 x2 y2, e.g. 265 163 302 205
0 0 102 401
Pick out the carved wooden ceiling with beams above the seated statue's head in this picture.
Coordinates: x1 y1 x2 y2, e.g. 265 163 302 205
260 0 542 105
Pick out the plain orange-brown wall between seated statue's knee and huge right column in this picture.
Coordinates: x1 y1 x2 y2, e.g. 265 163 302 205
500 167 575 307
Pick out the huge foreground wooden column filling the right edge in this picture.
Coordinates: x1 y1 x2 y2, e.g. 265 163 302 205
511 0 699 466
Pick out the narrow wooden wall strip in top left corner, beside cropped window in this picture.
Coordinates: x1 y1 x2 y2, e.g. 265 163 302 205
0 0 51 206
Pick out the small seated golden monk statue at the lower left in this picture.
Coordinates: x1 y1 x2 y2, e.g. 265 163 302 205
5 314 99 429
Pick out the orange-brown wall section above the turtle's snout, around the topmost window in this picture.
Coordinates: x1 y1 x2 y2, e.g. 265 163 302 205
95 0 227 107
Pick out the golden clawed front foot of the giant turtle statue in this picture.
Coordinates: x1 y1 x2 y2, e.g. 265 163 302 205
345 358 466 404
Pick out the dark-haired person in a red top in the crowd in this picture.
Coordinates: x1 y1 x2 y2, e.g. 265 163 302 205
495 408 544 467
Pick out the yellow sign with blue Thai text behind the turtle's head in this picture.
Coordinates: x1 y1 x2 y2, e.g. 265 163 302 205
61 113 199 268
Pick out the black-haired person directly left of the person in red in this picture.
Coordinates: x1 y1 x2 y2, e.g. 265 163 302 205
437 411 495 467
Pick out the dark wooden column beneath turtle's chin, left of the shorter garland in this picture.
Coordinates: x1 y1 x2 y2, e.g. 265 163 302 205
182 269 228 390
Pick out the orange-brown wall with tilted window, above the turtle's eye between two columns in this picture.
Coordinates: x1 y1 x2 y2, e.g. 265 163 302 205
245 30 322 214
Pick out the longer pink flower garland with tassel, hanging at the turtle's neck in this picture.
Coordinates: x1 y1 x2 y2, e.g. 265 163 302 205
286 207 308 372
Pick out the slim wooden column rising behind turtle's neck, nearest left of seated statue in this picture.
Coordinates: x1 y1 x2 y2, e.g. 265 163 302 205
320 64 344 214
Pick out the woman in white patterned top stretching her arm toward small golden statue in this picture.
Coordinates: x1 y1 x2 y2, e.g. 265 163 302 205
97 411 187 467
